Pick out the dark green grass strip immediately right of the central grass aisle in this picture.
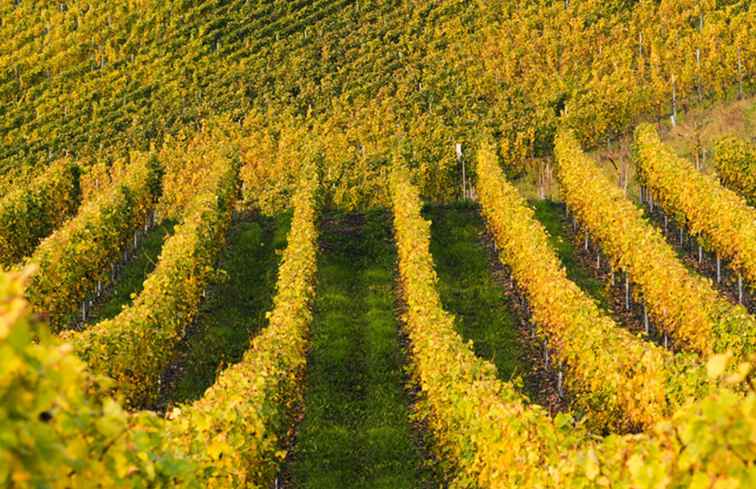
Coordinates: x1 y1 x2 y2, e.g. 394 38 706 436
425 205 524 380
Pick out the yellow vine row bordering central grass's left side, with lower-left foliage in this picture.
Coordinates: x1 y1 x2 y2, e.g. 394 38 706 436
0 163 317 488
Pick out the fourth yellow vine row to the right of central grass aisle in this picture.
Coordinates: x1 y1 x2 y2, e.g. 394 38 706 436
634 124 756 288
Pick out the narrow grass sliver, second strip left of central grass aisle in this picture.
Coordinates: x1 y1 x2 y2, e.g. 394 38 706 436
89 221 175 323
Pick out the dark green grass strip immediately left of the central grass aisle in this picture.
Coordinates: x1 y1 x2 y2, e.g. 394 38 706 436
163 215 290 403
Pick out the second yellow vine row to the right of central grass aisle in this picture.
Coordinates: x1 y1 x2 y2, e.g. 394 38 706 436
477 145 705 430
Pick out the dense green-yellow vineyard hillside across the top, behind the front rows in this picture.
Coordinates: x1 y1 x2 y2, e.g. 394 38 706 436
0 0 756 208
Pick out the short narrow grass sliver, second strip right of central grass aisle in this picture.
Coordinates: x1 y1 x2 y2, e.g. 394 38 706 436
531 200 610 311
